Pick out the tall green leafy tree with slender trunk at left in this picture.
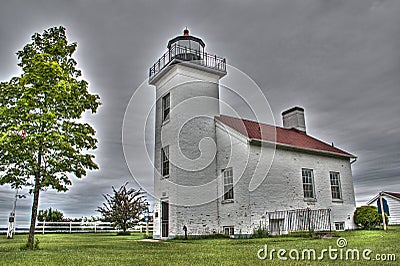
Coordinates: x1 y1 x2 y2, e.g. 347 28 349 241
0 26 100 249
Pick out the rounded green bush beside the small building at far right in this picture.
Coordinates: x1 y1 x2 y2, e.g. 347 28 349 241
354 206 388 230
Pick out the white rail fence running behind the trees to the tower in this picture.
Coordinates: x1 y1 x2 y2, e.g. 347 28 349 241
0 222 153 234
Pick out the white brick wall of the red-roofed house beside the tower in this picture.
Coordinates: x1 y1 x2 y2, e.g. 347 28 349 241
217 123 355 234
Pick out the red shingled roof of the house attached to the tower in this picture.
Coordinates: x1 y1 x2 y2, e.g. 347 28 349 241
215 115 355 158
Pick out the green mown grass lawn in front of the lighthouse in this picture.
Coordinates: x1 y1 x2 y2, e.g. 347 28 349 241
0 227 400 265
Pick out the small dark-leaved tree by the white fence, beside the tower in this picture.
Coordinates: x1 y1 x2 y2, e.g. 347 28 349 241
97 183 149 233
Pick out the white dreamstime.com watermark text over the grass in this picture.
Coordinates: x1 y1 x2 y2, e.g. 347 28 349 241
257 237 396 261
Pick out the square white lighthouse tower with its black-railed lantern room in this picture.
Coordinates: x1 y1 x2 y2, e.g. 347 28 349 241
149 29 226 238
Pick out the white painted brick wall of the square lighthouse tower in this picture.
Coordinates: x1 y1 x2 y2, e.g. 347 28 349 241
154 65 219 238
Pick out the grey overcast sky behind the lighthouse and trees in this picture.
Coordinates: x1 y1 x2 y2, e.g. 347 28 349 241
0 0 400 226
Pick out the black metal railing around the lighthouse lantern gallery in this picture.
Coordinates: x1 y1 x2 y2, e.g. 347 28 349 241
149 44 226 79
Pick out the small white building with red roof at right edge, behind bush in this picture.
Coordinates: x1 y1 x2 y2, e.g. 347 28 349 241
367 191 400 225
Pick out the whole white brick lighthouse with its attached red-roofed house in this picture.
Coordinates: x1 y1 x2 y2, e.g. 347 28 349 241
149 30 355 238
